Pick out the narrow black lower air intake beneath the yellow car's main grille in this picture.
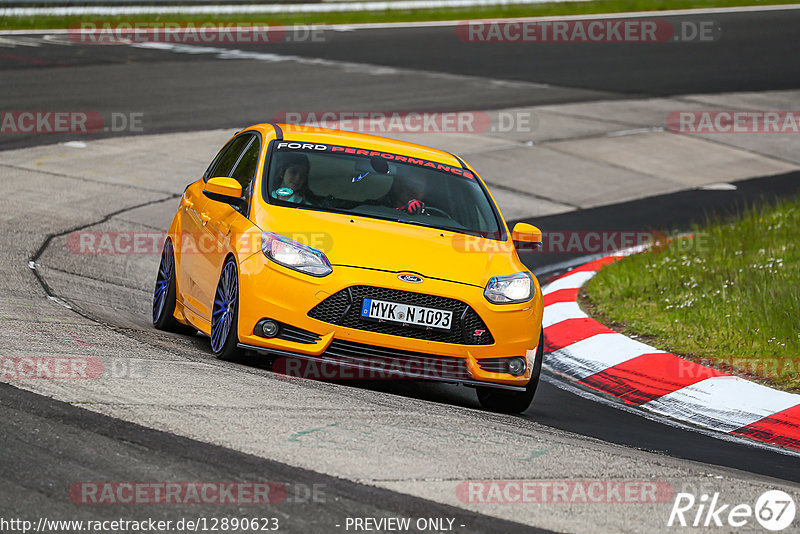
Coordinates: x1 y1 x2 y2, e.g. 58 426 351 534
322 339 472 380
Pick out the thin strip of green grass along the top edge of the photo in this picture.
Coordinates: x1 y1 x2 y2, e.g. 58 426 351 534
0 0 797 30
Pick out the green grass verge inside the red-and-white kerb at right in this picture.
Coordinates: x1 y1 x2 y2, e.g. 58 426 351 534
581 197 800 392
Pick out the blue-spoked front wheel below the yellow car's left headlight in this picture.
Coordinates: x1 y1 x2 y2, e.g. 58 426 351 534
211 258 241 361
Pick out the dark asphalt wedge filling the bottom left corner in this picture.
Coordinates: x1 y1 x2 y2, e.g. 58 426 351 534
0 384 548 532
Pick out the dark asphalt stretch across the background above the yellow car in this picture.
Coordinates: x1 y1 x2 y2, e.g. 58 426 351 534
0 10 800 148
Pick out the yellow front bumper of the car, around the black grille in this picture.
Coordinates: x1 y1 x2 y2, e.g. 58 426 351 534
233 254 542 389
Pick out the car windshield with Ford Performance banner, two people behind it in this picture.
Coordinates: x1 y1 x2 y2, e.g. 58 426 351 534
263 141 501 239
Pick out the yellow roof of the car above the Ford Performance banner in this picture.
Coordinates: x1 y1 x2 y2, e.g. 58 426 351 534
248 123 461 167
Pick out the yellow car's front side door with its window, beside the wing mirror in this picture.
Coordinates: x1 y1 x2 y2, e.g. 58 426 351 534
183 134 252 321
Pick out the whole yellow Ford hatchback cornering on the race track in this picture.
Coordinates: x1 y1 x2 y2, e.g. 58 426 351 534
153 124 543 413
